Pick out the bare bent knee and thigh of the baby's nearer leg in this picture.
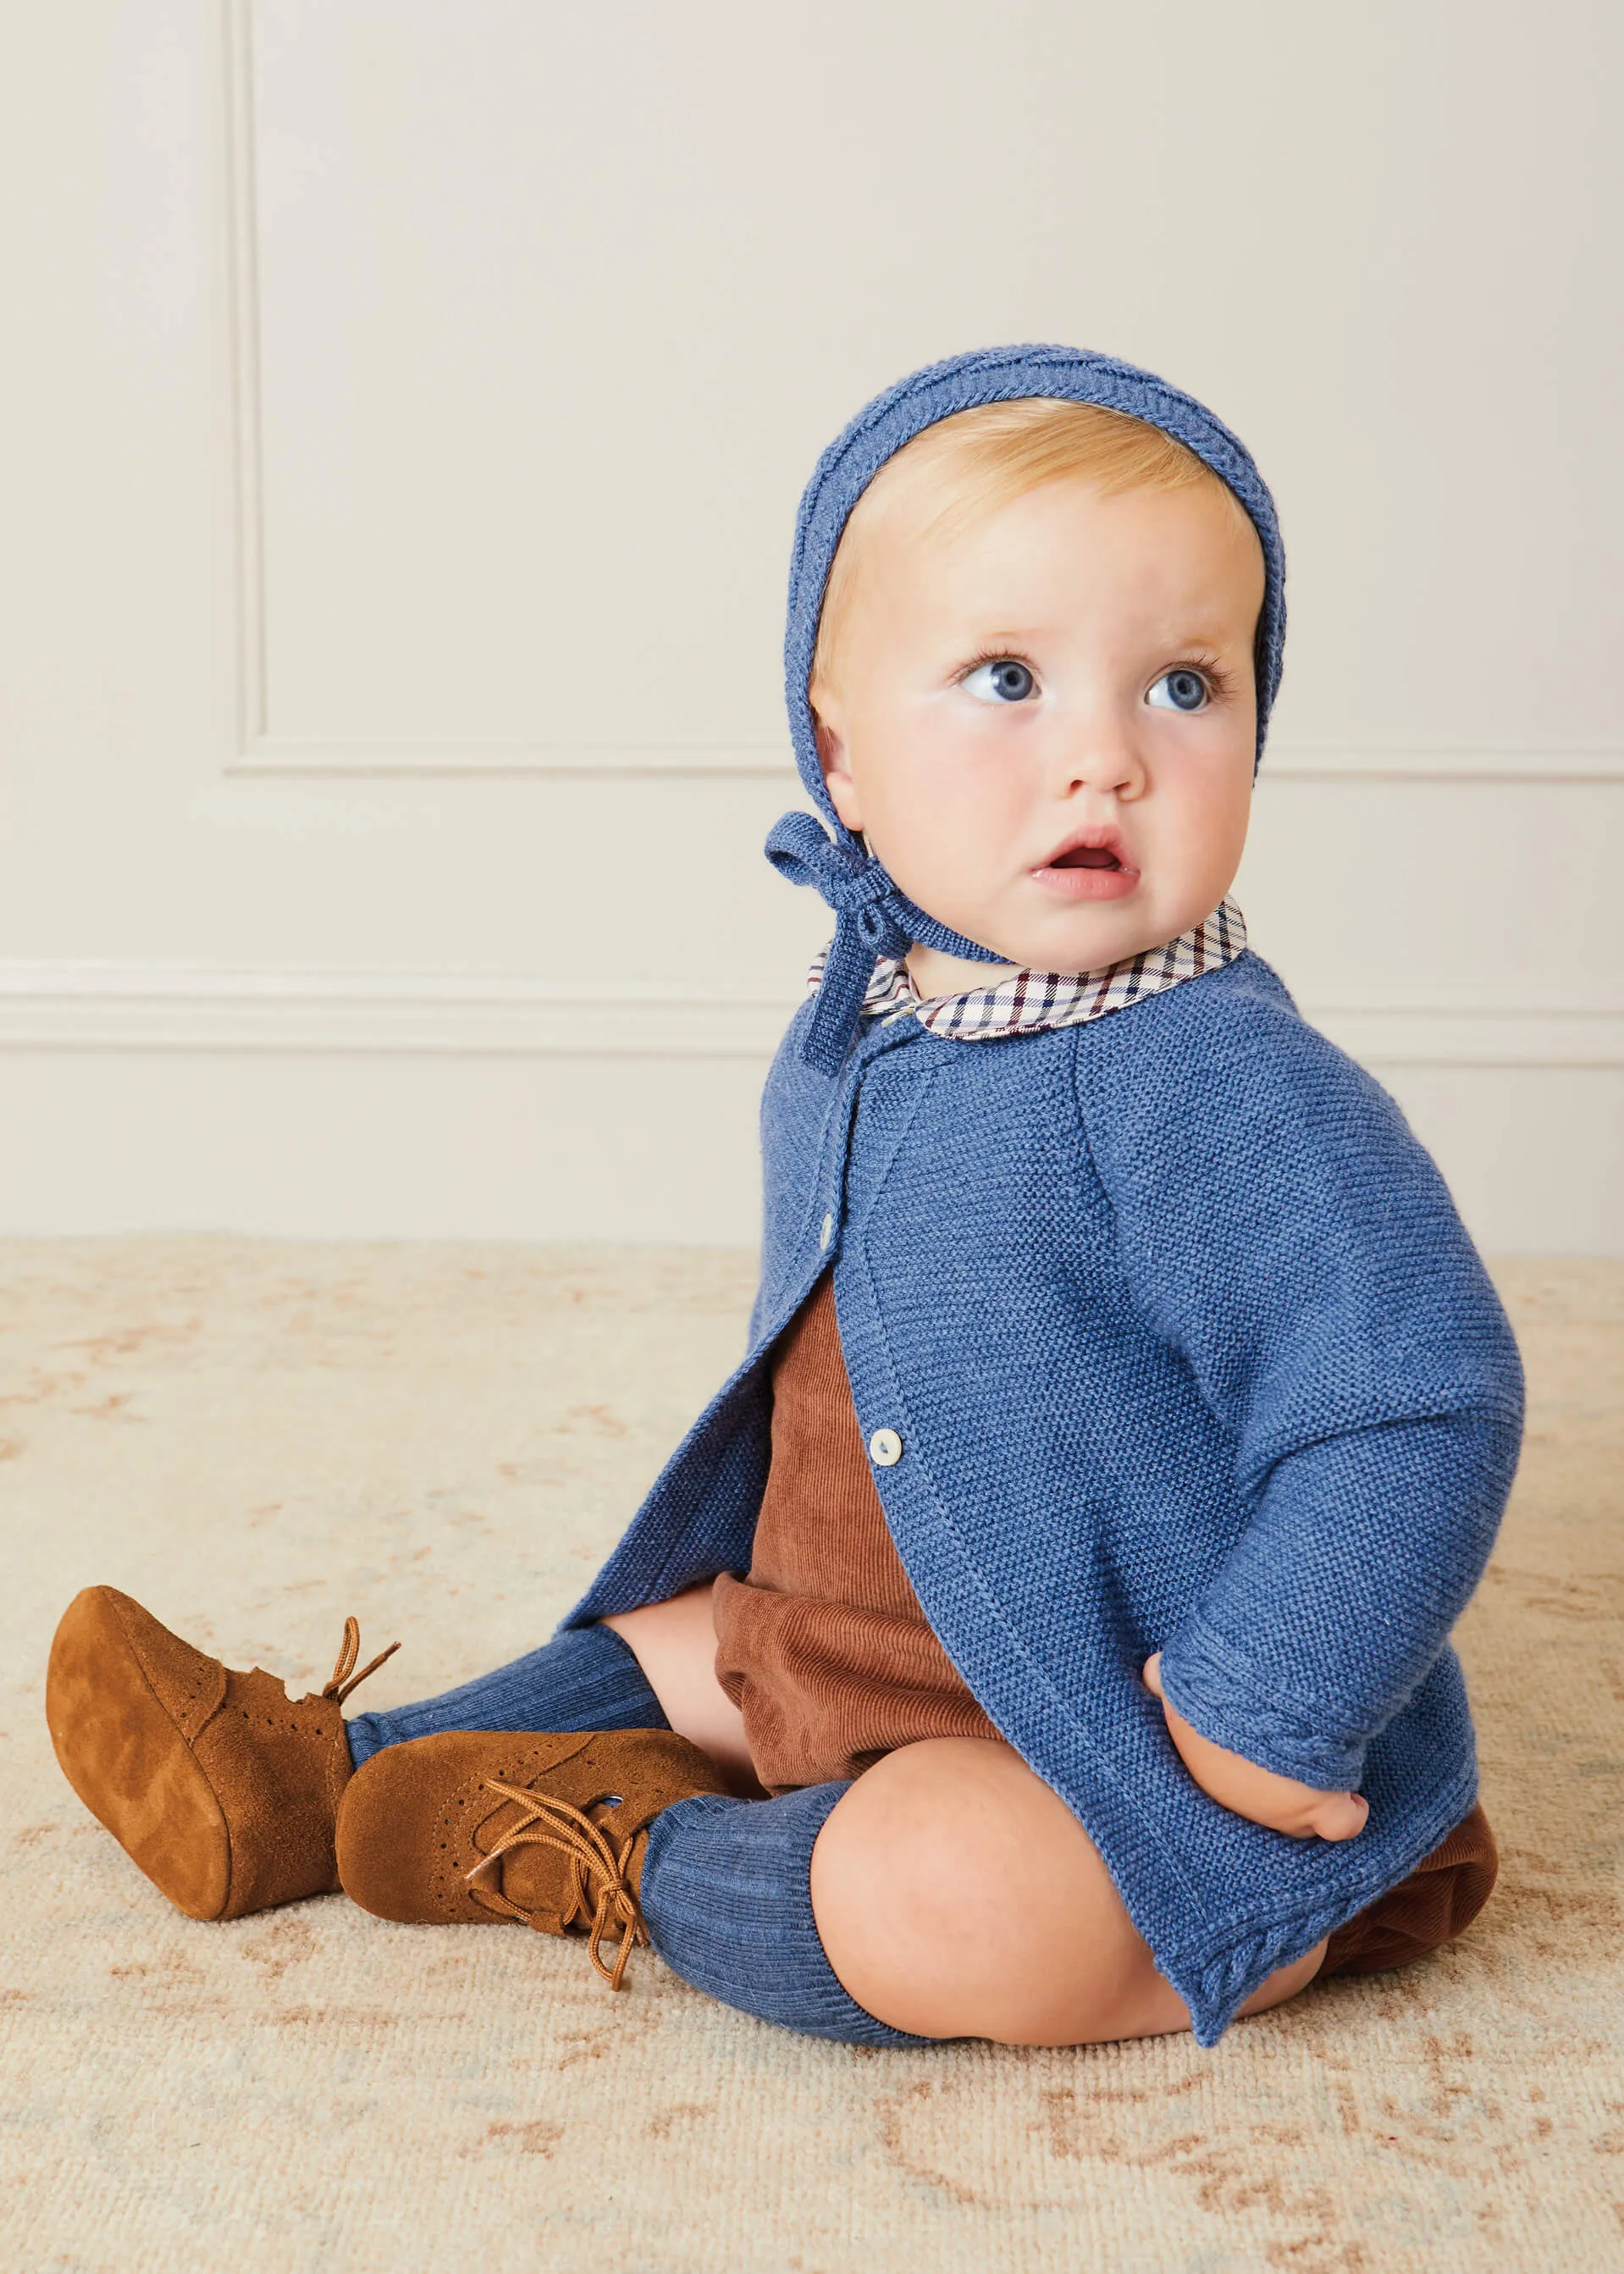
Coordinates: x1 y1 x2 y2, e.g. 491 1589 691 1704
812 1737 1323 2044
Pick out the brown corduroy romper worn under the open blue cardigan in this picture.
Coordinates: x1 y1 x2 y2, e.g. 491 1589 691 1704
714 1275 1497 1974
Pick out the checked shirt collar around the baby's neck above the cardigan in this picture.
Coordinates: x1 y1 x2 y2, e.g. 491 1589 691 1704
808 900 1246 1042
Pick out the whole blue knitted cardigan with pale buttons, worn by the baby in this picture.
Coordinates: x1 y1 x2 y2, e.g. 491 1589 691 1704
566 950 1522 2044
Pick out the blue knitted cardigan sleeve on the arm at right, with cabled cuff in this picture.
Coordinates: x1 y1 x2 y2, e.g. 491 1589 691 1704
1078 982 1522 1790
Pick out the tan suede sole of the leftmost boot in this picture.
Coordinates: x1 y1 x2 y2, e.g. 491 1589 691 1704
46 1587 232 1919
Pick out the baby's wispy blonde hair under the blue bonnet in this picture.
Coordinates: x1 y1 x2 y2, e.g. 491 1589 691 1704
808 396 1251 703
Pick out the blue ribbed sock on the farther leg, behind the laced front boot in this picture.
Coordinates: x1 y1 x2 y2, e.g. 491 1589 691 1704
345 1626 671 1769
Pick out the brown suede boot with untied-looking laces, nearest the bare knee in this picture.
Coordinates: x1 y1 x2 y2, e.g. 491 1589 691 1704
339 1729 728 1989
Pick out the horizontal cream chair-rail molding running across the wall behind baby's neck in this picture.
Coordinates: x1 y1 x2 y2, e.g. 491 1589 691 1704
0 962 1624 1066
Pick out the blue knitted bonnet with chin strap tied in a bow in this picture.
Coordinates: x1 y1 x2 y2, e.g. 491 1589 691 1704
766 348 1285 1073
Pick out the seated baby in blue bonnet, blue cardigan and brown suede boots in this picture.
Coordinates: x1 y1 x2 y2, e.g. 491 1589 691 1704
47 348 1522 2044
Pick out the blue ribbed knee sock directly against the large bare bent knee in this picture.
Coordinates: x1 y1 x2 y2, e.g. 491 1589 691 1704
642 1785 935 2044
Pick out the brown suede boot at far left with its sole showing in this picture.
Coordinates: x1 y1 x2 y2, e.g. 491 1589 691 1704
46 1587 398 1919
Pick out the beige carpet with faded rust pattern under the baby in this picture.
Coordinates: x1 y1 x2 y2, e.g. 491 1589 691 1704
0 1239 1624 2274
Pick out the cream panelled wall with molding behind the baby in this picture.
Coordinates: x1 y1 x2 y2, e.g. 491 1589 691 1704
0 0 1624 1251
